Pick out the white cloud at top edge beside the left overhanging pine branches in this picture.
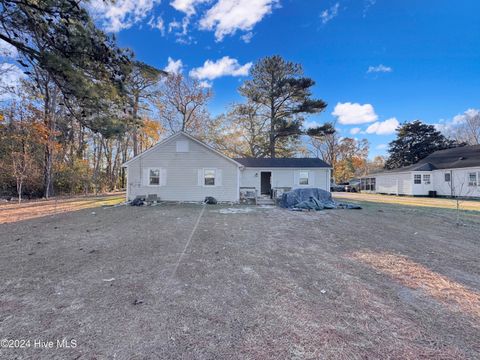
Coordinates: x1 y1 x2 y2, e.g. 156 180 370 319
89 0 161 32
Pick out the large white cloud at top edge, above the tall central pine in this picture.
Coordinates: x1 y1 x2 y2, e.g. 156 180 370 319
200 0 278 41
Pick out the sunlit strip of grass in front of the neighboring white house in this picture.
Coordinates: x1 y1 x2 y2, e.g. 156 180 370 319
334 192 480 211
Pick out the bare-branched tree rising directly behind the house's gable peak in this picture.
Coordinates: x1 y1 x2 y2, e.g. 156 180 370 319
155 74 212 135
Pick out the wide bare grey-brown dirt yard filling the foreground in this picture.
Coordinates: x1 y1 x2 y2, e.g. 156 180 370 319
0 198 480 359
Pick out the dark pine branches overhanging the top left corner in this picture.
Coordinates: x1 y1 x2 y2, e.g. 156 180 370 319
0 0 131 107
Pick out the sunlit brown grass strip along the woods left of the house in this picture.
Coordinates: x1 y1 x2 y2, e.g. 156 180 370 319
0 193 125 224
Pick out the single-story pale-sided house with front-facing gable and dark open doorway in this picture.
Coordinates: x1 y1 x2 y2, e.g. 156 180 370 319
123 132 331 202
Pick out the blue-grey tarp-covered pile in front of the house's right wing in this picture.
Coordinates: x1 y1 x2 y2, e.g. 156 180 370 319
280 188 361 210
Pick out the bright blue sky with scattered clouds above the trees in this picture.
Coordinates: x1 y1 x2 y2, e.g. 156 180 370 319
2 0 480 156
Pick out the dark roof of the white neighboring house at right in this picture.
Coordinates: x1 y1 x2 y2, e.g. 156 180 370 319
375 145 480 174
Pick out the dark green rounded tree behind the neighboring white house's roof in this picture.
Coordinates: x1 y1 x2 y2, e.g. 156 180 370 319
385 120 455 169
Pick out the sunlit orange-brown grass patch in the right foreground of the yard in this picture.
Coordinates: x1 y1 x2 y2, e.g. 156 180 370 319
353 252 480 319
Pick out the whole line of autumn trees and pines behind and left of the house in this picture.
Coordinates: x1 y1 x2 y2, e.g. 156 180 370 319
0 0 376 199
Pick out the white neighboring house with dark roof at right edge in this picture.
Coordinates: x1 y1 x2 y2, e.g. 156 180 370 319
361 145 480 197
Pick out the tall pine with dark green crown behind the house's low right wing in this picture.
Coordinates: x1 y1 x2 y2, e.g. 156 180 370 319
239 56 327 158
